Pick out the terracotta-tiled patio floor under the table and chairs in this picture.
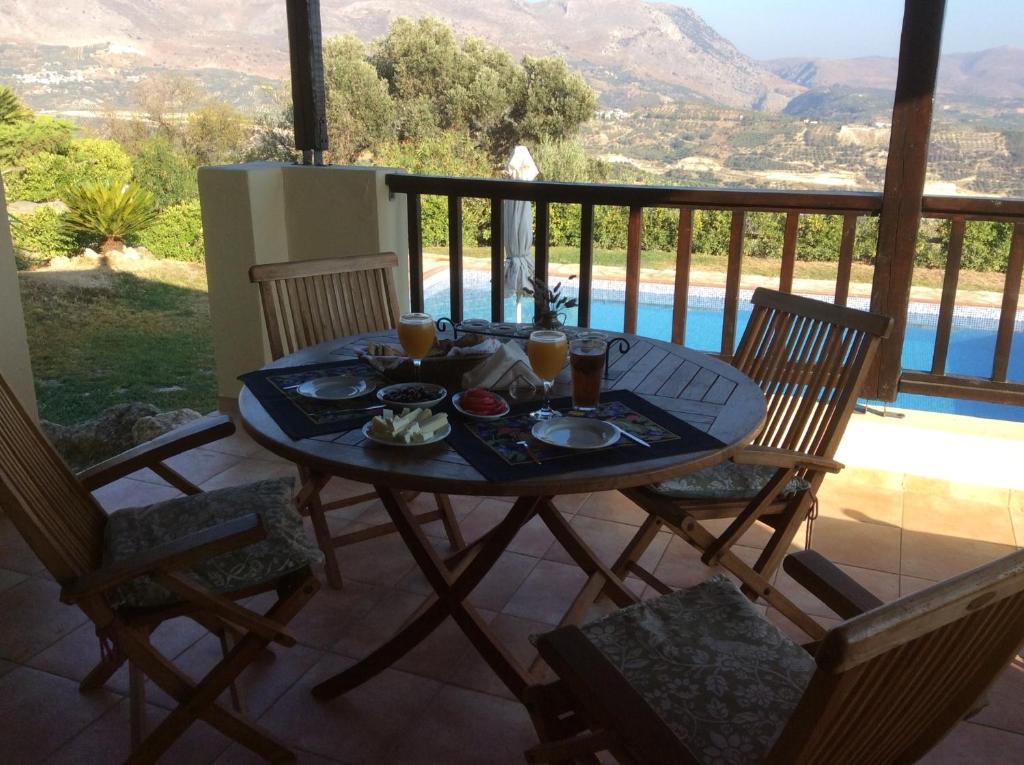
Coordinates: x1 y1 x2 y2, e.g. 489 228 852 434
0 415 1024 765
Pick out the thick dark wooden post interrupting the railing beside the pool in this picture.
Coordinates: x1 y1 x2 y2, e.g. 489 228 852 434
864 0 946 401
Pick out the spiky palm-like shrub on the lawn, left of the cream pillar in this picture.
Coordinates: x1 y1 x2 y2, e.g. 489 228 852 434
65 183 159 253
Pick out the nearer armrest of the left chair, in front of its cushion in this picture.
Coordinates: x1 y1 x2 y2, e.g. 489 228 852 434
60 513 266 603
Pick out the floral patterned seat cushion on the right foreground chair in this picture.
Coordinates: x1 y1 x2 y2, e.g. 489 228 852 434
581 576 815 765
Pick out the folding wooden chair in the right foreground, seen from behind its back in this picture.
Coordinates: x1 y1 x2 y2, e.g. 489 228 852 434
526 550 1024 765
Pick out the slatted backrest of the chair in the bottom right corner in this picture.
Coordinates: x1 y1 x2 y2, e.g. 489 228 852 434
769 550 1024 765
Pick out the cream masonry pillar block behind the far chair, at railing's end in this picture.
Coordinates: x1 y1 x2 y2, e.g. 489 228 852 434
199 163 409 411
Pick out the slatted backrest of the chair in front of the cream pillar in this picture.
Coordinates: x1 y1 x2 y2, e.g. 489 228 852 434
249 253 398 358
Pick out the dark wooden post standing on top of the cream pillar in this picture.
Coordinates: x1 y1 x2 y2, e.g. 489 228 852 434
287 0 328 165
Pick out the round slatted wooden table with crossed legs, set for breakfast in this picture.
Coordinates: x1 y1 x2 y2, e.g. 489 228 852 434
239 325 765 698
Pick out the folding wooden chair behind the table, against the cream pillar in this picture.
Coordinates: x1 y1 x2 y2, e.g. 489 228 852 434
249 252 465 588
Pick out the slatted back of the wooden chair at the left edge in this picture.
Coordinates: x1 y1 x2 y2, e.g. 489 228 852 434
0 376 106 583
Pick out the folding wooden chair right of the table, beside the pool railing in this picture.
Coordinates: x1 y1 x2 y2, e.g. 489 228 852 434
566 289 892 633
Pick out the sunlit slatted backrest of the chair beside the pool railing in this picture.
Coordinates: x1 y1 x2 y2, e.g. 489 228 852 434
734 289 892 458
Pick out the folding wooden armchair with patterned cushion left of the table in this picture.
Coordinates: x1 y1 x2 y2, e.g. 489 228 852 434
0 377 322 763
